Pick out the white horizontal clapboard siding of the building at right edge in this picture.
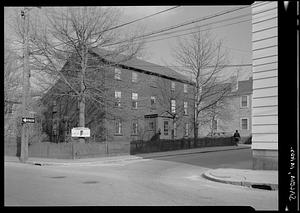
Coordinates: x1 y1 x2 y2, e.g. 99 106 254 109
252 2 278 150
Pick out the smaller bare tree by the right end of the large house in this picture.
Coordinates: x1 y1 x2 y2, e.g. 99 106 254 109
174 29 231 141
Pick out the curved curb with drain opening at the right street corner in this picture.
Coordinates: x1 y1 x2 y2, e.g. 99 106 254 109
202 170 278 190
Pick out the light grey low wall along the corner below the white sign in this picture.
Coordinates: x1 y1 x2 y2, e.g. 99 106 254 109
4 141 130 159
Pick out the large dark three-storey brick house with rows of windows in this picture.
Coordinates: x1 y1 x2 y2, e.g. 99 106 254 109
42 49 194 145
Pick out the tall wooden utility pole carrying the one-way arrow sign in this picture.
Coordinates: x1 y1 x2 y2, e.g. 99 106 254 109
20 7 30 163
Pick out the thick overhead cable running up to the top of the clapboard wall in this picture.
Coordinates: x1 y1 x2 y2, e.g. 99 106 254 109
103 5 249 47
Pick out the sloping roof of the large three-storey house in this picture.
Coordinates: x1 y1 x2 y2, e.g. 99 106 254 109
91 48 191 84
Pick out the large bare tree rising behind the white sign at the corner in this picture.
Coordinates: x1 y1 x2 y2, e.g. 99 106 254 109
8 7 142 143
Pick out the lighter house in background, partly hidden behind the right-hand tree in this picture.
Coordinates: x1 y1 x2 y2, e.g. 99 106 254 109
199 77 253 140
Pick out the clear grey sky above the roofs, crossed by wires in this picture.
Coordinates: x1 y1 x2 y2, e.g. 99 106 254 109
5 5 252 80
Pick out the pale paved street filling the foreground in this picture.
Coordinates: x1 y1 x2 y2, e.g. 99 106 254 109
5 148 278 210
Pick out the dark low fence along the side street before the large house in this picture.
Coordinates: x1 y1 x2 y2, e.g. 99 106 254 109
130 137 235 155
